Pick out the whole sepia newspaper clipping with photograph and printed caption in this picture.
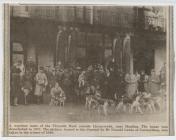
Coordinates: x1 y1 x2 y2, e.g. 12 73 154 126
4 4 174 136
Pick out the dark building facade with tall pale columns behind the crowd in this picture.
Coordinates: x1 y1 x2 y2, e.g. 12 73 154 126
10 6 166 72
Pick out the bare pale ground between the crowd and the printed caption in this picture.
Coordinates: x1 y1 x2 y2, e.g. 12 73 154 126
10 104 166 123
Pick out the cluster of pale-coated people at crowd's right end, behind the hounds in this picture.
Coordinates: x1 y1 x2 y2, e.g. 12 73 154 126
125 64 166 98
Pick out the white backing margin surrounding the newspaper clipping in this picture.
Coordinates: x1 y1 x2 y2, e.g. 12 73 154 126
0 0 176 140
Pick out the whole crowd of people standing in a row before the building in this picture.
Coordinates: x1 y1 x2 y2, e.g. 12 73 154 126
10 58 166 106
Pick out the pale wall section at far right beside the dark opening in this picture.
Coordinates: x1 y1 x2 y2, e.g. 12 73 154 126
155 47 166 74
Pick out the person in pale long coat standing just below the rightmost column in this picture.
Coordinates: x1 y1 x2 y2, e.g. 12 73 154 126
125 73 137 98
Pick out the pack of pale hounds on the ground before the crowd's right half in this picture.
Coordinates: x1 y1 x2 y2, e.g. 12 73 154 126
85 91 166 116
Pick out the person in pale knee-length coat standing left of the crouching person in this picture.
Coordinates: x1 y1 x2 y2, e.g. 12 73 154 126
34 67 48 104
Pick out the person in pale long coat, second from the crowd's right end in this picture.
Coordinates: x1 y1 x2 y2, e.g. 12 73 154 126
149 70 160 95
